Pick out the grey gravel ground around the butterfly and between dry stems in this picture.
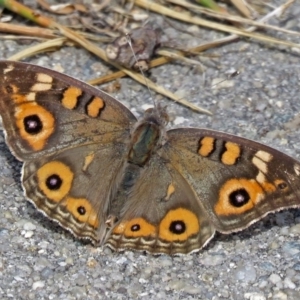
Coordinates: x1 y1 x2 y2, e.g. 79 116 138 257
0 1 300 300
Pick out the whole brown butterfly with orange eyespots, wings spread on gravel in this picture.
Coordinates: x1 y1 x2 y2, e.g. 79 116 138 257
0 61 300 254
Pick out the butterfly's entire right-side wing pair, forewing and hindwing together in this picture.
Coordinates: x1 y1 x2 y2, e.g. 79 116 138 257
107 128 300 254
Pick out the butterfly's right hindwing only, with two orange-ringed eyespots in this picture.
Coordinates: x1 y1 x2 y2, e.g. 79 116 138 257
107 154 215 254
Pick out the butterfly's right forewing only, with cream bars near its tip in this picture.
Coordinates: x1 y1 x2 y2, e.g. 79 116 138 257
165 128 300 233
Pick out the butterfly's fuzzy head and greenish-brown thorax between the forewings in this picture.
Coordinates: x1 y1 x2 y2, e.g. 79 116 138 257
128 106 168 166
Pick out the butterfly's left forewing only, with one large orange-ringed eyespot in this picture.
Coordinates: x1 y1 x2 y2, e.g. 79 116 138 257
0 61 136 160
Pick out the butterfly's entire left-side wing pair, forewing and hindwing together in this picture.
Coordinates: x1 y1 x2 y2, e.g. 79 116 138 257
0 61 136 241
